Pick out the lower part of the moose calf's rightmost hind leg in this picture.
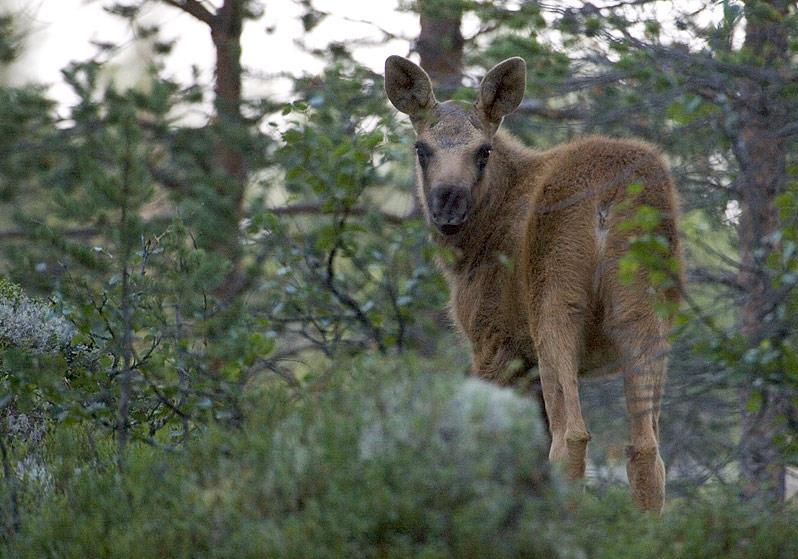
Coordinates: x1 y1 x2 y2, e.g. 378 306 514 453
623 319 668 511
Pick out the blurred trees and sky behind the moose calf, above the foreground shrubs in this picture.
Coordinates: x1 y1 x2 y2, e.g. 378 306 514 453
0 0 798 556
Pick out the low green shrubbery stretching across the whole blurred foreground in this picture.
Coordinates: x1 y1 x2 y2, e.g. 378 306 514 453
6 359 798 559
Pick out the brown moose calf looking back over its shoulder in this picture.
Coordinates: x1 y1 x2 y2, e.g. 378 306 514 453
385 56 679 510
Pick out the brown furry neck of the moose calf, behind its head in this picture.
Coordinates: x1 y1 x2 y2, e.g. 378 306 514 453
434 132 530 273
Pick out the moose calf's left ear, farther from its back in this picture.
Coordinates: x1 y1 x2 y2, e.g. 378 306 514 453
385 55 437 118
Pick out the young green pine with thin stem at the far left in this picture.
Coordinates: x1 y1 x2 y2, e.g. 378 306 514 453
2 62 274 444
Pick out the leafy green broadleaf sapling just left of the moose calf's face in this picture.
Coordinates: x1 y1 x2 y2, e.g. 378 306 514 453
252 61 444 354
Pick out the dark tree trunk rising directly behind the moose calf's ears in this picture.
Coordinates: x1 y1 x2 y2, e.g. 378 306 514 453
416 0 463 96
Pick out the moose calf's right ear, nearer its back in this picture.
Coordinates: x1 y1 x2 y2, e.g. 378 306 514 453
477 56 526 126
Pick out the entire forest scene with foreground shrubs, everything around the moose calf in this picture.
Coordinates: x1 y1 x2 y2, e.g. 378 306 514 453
0 0 798 557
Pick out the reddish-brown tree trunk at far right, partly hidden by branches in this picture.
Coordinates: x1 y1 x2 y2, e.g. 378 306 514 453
733 0 789 501
